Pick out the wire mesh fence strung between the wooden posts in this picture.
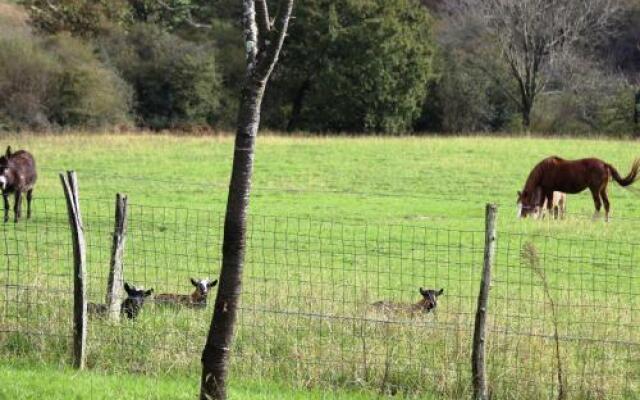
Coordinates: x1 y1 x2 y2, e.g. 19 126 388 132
0 198 640 398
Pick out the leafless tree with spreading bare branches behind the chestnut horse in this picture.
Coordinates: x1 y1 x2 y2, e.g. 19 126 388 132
467 0 618 129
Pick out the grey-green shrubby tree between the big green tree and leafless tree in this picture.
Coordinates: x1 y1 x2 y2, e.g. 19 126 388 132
415 2 517 132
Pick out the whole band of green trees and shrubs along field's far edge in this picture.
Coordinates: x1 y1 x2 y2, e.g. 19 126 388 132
0 0 640 135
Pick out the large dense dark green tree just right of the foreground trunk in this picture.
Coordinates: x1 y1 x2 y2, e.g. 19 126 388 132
268 0 434 133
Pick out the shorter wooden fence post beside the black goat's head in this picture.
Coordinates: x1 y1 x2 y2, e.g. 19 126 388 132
105 193 127 322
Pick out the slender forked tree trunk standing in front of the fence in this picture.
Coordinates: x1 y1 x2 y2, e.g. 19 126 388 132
200 0 293 400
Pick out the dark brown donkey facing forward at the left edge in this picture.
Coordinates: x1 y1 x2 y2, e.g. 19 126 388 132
0 146 38 222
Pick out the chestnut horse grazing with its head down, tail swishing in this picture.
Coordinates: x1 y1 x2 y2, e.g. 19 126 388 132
518 156 640 221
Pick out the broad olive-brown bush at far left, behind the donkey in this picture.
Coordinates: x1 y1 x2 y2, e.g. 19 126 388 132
0 27 130 129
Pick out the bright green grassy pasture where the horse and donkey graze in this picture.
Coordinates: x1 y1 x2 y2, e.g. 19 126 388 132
0 135 640 399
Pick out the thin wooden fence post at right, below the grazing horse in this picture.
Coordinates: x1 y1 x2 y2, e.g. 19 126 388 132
471 204 498 400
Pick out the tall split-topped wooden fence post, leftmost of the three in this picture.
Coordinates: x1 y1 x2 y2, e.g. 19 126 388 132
60 171 87 369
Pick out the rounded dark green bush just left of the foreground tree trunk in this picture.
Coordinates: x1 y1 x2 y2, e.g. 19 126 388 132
101 24 220 128
